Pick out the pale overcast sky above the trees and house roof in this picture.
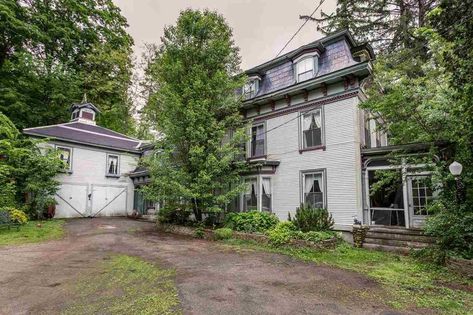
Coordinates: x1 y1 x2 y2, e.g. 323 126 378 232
115 0 336 70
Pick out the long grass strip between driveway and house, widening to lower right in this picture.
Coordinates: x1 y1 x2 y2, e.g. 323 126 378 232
225 239 473 314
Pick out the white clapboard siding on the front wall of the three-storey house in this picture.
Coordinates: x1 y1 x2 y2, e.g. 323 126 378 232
266 97 362 226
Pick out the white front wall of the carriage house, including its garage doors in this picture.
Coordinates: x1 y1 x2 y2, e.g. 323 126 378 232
48 142 139 218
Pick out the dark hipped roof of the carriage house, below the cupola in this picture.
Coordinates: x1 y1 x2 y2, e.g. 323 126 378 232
23 122 144 153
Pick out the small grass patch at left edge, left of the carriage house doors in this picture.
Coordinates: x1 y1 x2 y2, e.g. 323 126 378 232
0 220 64 246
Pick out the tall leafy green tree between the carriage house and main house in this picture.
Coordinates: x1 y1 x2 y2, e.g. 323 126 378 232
146 9 245 220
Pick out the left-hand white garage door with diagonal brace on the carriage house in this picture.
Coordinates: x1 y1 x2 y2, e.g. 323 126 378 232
56 184 89 218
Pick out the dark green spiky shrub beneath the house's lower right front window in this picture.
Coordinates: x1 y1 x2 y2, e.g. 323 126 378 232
292 204 334 232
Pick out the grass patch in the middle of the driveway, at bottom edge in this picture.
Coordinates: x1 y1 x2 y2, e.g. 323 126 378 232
64 255 181 314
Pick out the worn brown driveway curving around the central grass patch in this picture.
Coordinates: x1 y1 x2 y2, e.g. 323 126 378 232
0 218 402 314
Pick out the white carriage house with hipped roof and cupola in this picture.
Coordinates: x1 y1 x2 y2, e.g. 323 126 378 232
23 103 142 218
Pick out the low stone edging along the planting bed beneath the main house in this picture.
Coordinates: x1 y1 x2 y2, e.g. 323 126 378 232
157 222 338 249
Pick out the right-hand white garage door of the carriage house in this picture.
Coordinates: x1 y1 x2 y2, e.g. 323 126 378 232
90 185 128 217
